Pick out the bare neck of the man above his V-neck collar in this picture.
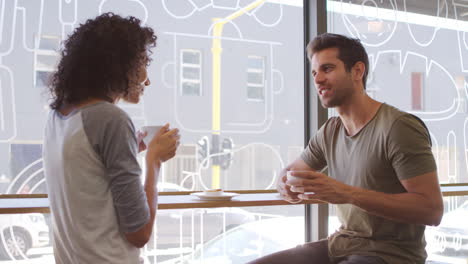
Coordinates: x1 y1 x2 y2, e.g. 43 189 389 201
336 91 382 136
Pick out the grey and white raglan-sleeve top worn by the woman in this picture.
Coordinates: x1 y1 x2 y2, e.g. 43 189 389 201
43 102 150 264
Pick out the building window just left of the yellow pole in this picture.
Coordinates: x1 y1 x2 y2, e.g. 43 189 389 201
180 50 202 96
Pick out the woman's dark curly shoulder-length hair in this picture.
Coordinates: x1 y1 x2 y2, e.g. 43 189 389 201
49 13 157 110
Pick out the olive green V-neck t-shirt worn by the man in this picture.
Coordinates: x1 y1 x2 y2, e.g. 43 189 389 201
301 104 436 264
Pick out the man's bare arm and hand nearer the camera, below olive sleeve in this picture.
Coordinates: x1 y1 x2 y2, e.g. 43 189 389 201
287 172 443 226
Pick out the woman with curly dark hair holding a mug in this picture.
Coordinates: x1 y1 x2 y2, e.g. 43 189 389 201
44 13 180 264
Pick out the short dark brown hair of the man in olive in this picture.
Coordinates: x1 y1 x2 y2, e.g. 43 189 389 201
307 33 369 90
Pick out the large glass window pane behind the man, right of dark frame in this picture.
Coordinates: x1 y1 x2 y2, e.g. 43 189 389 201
327 0 468 263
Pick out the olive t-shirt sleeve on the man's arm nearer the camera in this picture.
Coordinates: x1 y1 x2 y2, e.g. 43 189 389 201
387 114 437 180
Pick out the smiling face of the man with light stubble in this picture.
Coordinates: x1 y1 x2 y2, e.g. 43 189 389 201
311 48 354 108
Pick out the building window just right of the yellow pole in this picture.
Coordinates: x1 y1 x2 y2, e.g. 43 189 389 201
247 56 265 101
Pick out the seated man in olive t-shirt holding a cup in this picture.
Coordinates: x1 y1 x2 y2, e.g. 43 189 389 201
251 33 443 264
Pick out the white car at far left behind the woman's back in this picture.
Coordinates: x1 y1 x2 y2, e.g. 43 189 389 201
0 213 49 260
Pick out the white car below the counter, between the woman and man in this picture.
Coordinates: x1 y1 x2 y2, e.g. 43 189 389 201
161 216 339 264
